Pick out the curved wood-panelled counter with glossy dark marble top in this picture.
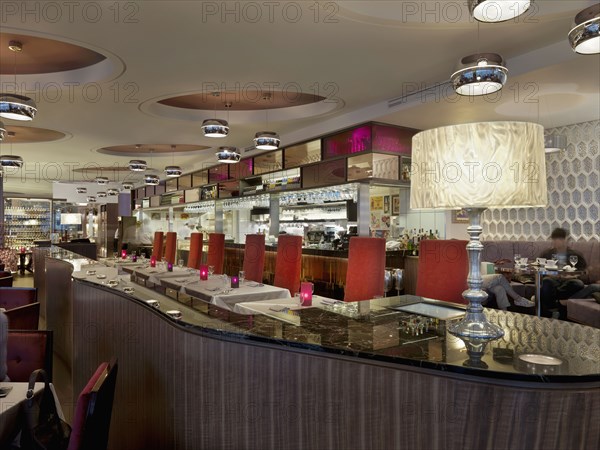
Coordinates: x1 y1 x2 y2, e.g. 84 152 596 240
36 248 600 449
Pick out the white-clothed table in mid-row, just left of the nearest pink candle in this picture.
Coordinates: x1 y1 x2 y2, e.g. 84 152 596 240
160 274 291 310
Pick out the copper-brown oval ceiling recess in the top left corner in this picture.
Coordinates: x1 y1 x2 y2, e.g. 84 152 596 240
0 33 106 75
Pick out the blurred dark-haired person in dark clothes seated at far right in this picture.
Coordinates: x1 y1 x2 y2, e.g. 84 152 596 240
540 228 587 319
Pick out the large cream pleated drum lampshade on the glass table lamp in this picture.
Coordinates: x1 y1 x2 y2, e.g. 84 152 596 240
410 122 548 209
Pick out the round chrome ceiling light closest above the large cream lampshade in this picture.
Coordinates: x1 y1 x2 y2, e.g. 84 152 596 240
450 53 508 96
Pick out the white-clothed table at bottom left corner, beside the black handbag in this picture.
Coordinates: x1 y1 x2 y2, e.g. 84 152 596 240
0 382 45 449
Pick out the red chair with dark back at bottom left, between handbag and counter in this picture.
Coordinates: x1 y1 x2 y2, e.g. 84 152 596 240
68 358 119 450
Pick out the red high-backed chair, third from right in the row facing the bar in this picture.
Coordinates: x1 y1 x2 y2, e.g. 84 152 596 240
273 234 302 295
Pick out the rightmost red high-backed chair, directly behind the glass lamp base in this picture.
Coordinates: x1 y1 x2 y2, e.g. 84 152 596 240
416 239 469 304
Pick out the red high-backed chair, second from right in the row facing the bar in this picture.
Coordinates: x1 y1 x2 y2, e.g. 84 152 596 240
344 236 385 302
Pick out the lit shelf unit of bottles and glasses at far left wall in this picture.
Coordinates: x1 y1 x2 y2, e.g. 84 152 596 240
4 198 52 250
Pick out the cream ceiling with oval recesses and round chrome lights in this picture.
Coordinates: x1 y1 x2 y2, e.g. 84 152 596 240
0 0 600 197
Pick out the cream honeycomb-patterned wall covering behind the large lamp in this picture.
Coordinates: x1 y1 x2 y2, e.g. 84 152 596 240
483 120 600 241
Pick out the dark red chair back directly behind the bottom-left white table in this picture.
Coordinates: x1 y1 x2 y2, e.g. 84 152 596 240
6 330 52 382
